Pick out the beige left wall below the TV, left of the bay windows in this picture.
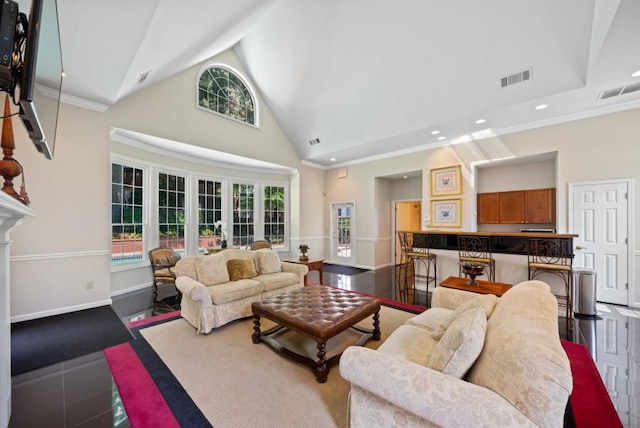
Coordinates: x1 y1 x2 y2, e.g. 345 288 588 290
10 104 111 321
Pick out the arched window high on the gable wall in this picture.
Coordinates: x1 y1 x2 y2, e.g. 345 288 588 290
198 64 257 125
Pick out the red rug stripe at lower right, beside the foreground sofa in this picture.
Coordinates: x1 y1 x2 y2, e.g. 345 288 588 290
562 340 622 428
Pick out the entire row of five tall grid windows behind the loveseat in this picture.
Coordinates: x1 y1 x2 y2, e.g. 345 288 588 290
111 159 288 265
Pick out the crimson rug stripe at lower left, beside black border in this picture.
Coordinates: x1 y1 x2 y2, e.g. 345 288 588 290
104 343 180 428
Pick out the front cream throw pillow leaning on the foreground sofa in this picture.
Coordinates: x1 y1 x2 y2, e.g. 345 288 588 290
427 307 487 379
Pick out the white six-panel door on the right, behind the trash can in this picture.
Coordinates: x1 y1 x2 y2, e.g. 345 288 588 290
570 181 629 305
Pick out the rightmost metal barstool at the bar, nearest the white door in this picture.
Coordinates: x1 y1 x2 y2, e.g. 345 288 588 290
527 238 573 328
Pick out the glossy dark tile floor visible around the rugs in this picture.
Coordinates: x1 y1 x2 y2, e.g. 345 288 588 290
9 268 640 428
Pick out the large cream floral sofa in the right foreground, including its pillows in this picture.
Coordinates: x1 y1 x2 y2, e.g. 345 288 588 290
340 281 573 427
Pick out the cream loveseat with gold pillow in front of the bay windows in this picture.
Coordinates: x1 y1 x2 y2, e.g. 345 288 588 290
173 248 309 334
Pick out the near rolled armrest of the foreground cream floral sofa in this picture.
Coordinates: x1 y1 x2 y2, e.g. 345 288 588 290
340 346 534 426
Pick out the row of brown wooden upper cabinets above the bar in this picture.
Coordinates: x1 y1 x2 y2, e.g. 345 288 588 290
478 189 556 224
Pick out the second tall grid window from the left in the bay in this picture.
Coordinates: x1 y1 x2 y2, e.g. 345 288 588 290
158 173 186 255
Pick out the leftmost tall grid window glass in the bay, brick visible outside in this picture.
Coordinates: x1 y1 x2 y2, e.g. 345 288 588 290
111 163 144 265
